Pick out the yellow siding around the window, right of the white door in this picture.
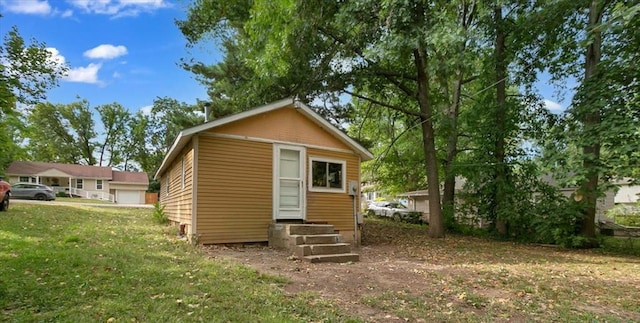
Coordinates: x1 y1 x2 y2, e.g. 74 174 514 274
305 148 360 231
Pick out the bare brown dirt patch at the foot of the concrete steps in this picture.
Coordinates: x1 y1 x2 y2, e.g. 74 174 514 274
206 245 433 322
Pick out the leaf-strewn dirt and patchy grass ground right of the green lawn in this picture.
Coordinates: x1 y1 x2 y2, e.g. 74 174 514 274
200 221 640 322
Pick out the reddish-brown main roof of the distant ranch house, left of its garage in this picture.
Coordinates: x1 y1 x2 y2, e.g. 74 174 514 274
7 161 113 179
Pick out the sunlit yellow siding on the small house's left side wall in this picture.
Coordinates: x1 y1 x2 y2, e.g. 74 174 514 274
160 144 193 225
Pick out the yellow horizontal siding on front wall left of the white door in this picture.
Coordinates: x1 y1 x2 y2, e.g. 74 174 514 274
197 136 273 244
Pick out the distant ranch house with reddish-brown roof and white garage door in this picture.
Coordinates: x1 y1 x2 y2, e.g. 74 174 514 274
6 161 149 204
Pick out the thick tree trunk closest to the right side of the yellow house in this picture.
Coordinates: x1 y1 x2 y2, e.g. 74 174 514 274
413 44 444 238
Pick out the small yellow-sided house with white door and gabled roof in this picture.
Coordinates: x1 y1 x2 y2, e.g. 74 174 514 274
155 99 373 244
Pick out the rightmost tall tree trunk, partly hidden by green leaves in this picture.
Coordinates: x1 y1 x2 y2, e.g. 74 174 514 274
580 0 603 243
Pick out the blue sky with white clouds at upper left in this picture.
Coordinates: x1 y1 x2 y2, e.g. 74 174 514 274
0 0 222 112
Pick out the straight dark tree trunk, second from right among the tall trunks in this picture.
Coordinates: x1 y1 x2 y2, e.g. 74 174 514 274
493 4 507 234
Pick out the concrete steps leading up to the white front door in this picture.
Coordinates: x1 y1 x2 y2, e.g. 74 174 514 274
269 223 360 263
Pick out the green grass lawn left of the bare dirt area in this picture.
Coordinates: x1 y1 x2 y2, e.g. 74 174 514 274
0 204 349 322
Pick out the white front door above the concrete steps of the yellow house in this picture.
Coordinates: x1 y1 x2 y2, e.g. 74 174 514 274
273 144 305 220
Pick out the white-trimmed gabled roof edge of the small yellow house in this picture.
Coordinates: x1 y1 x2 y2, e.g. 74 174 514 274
155 98 373 178
